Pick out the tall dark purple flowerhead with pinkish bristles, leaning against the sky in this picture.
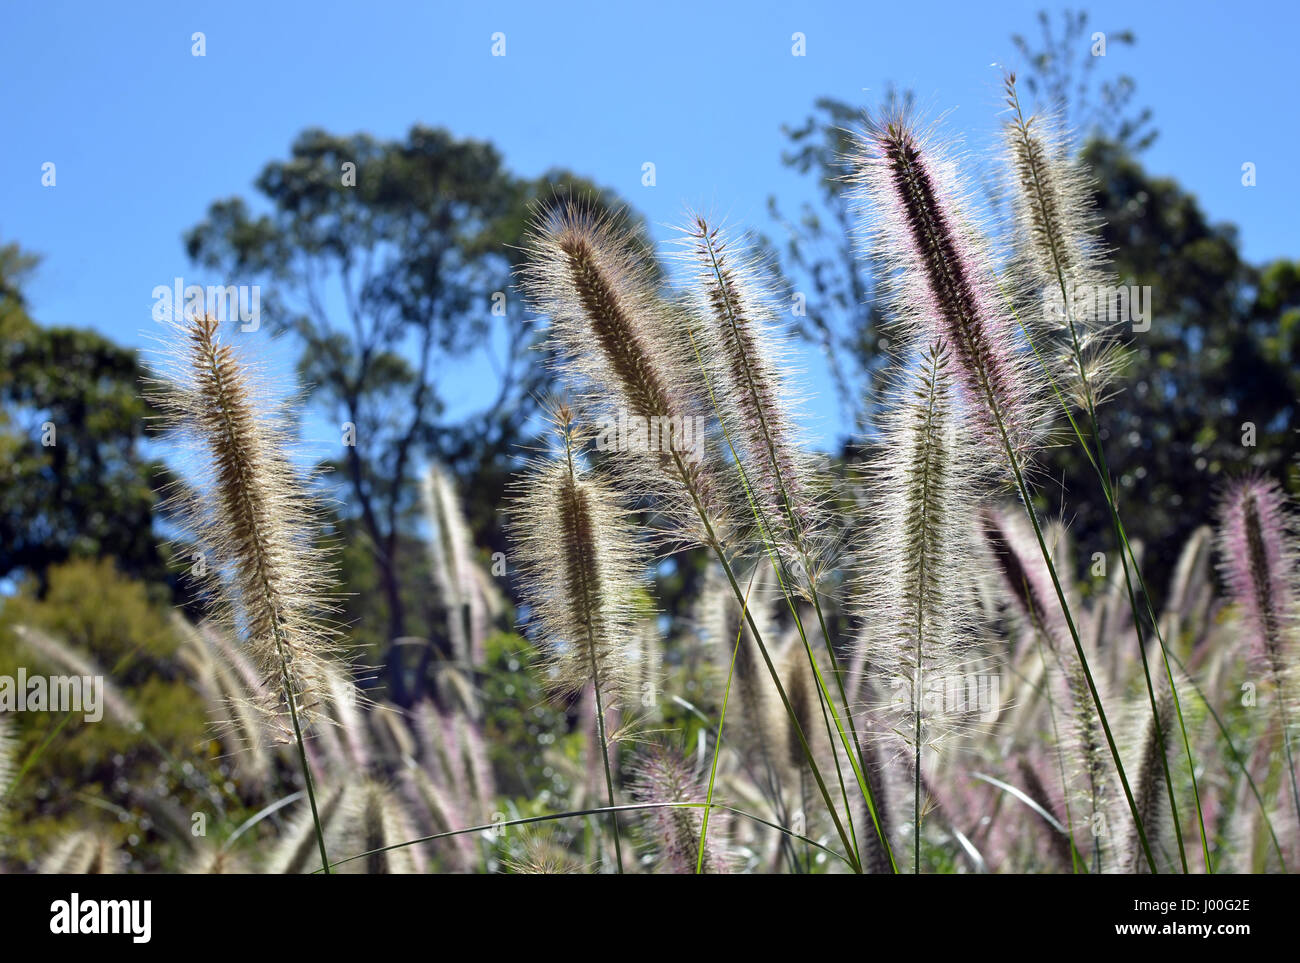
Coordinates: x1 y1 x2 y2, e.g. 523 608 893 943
854 109 1044 459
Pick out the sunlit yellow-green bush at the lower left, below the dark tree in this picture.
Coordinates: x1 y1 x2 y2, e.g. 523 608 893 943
0 559 216 869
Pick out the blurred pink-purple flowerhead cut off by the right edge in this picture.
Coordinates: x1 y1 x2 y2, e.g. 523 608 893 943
1218 477 1300 678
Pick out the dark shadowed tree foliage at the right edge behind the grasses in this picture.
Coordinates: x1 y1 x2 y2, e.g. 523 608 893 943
1048 142 1300 591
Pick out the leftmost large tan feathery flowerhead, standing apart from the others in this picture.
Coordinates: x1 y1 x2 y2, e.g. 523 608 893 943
148 316 337 724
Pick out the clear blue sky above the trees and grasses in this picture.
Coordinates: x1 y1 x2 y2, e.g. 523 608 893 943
0 0 1300 441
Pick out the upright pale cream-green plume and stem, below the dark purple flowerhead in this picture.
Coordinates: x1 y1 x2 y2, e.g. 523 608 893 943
862 343 979 872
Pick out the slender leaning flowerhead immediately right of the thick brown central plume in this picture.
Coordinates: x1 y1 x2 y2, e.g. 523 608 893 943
681 214 816 564
